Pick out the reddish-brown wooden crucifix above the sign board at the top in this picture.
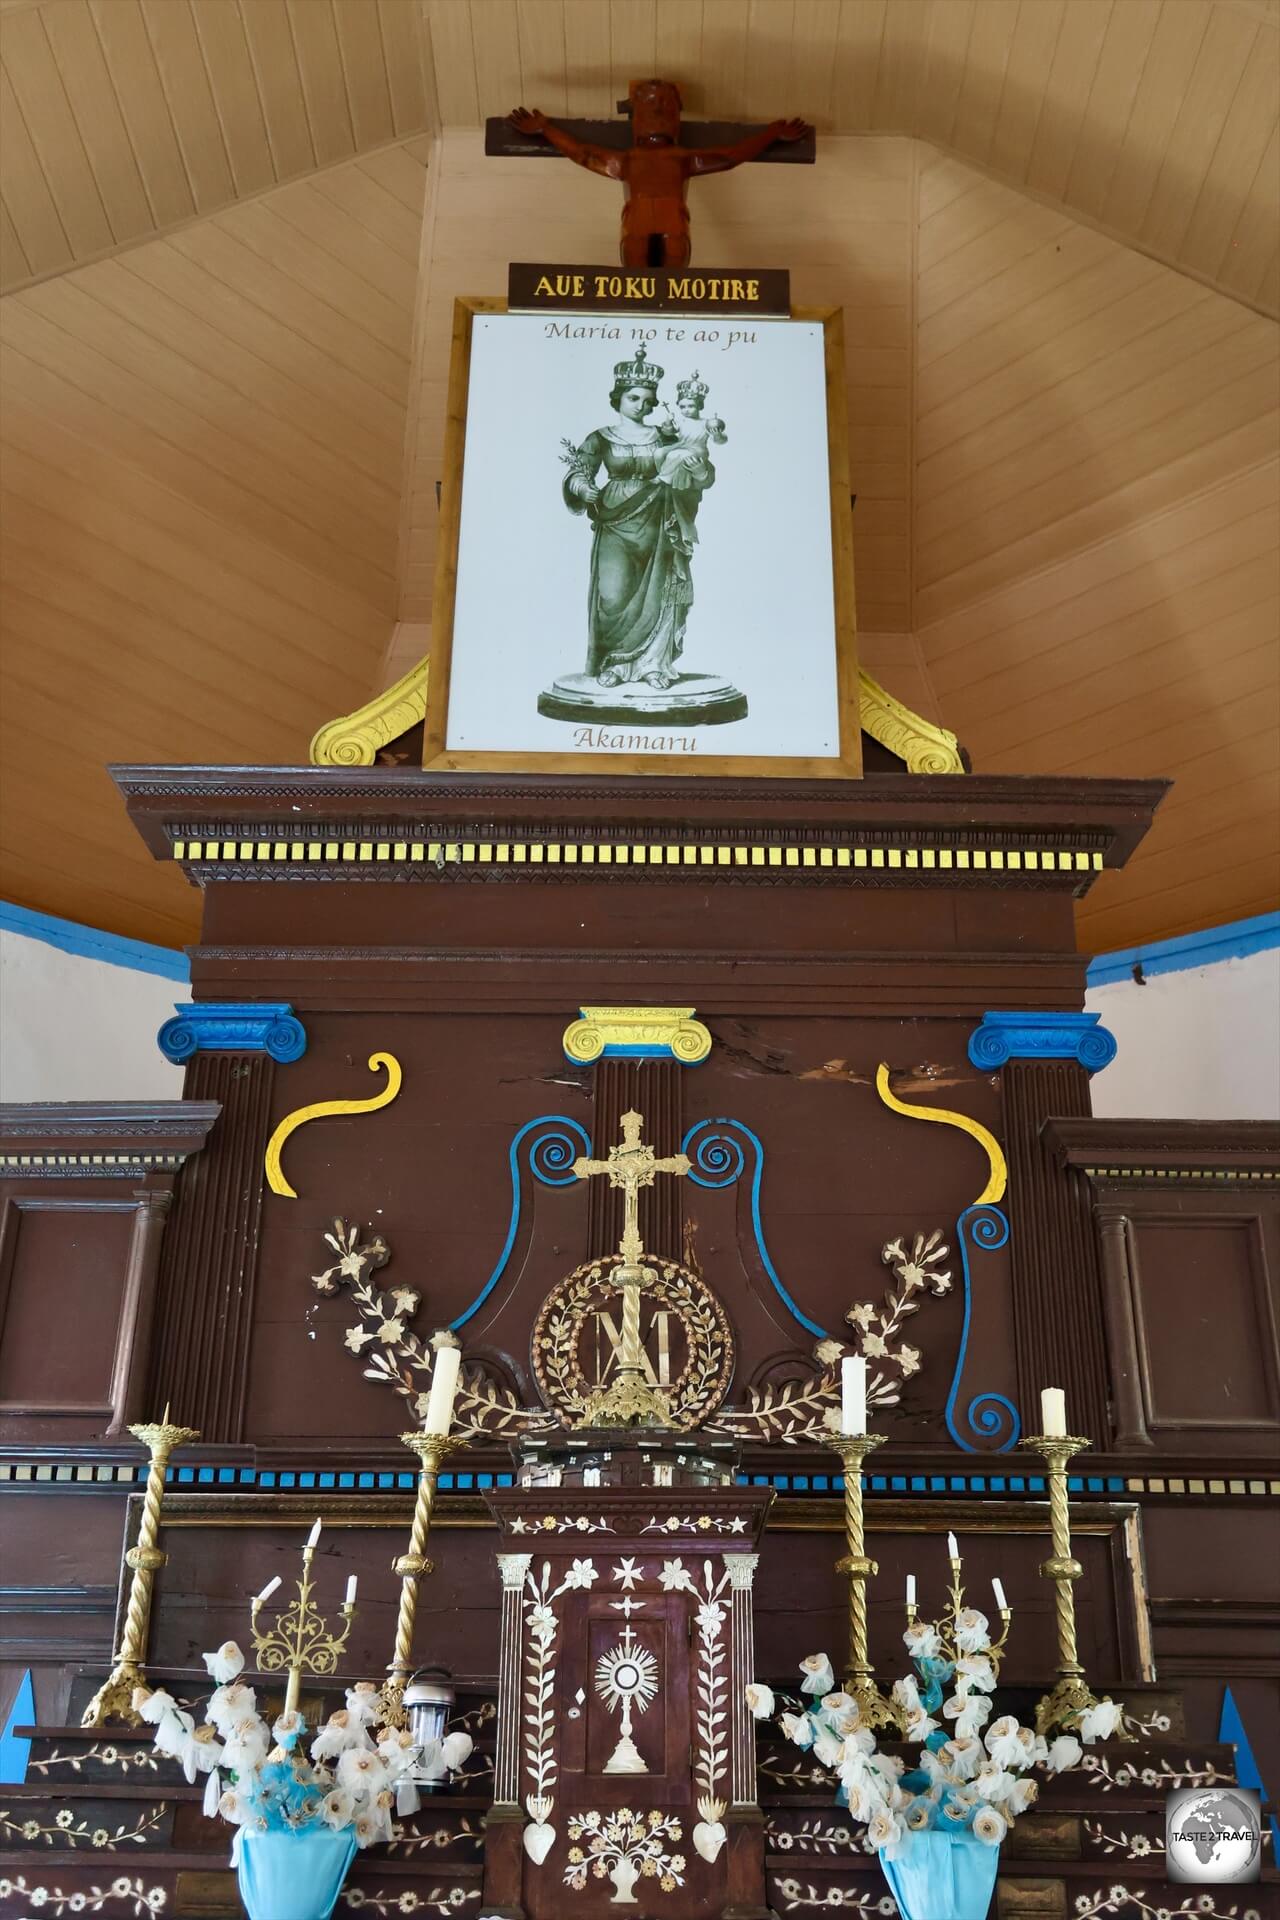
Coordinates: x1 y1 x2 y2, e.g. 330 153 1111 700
484 81 814 267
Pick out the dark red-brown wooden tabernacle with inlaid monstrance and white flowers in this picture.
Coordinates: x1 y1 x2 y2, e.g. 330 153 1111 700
484 1451 773 1920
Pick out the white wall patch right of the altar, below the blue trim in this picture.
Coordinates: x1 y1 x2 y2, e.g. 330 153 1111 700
1084 947 1280 1119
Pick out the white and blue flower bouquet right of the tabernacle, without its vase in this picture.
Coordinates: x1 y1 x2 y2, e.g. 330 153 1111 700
771 1609 1115 1860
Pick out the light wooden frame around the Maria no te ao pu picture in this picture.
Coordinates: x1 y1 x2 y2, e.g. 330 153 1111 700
422 296 862 780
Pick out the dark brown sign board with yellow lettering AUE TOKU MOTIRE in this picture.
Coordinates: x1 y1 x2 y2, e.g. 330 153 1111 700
507 261 791 321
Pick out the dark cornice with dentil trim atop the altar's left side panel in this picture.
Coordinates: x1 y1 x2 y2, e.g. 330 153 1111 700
0 1100 221 1179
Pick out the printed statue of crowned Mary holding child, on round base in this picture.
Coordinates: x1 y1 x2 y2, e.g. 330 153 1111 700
537 346 747 726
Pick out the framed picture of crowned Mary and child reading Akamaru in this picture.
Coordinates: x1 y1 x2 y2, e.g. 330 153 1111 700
422 300 862 778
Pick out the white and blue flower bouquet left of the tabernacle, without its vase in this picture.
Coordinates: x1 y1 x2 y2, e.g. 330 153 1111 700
132 1640 472 1866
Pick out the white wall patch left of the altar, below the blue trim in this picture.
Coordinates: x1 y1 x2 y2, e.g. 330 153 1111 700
0 922 190 1100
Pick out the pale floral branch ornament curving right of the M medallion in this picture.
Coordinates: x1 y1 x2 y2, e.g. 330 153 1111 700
716 1227 952 1446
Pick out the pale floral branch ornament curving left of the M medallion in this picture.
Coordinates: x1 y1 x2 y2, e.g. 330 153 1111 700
311 1219 555 1440
